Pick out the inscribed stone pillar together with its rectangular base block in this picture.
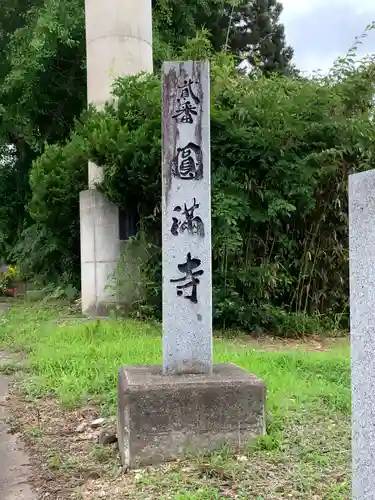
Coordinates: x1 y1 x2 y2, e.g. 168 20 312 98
117 61 265 467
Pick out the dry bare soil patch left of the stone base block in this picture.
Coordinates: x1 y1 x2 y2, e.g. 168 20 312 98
6 388 120 500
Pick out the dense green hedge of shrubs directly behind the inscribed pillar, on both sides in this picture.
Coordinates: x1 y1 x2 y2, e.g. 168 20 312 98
27 47 375 331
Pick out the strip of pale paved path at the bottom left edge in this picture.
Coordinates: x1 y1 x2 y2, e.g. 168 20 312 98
0 352 37 500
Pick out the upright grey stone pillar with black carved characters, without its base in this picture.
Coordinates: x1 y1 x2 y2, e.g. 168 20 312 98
162 62 212 374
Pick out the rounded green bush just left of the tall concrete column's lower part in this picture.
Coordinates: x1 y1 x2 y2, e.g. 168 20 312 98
13 125 87 288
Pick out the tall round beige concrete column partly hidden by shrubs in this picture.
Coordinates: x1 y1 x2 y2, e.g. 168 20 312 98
80 0 152 316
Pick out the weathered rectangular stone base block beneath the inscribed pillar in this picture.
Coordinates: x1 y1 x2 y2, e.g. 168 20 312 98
117 364 266 468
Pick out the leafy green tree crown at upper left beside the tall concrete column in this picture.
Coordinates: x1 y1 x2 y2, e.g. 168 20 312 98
0 0 86 150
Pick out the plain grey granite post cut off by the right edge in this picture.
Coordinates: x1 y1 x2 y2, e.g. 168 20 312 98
349 170 375 500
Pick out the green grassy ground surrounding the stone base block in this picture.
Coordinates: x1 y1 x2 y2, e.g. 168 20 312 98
0 304 350 500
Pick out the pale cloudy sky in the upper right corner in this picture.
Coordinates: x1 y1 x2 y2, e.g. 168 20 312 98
280 0 375 73
